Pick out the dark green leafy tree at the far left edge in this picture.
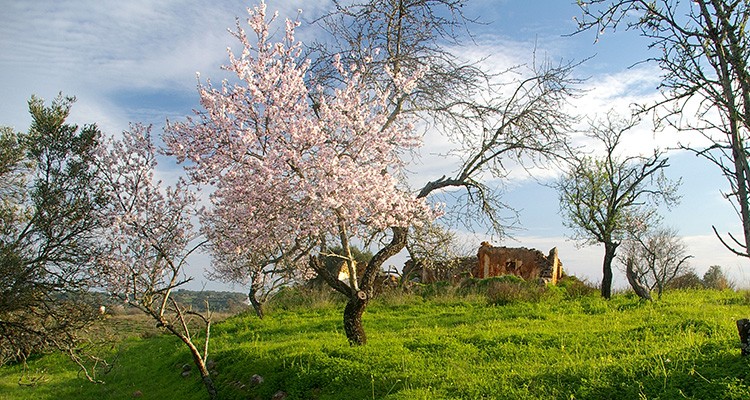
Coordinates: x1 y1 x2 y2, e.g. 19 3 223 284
0 94 103 380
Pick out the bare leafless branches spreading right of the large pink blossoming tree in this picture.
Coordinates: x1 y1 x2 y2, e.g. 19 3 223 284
314 0 580 234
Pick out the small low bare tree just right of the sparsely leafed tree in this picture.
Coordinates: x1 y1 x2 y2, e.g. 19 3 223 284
620 227 692 298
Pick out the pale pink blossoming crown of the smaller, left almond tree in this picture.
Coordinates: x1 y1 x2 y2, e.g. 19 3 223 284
99 125 196 301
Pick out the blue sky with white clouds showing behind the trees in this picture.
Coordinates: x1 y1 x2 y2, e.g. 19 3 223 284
0 0 750 291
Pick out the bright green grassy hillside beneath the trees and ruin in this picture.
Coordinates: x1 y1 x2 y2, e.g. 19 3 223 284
0 289 750 400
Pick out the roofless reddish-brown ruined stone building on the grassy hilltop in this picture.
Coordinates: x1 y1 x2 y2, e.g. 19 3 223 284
472 242 563 285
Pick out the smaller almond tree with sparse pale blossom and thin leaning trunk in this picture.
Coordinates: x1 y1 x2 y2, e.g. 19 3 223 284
100 125 216 398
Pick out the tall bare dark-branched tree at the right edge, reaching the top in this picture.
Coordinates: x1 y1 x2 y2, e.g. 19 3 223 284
578 0 750 257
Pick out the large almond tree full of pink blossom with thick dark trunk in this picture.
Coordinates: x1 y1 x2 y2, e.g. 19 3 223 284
165 2 434 344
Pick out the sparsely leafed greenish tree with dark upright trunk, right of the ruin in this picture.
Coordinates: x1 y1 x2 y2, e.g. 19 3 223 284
556 112 679 299
